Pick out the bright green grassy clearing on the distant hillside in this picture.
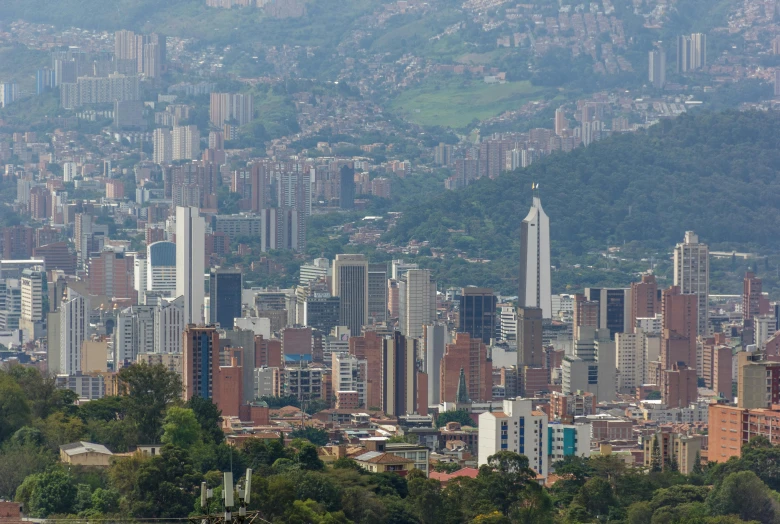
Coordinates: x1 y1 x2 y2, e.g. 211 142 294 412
391 76 551 128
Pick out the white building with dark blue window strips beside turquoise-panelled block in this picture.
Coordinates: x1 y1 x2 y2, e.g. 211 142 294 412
478 399 549 478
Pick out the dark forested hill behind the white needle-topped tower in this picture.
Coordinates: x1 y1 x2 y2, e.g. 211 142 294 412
388 112 780 260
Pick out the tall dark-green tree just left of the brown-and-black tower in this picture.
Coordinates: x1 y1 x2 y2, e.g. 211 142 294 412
119 363 182 444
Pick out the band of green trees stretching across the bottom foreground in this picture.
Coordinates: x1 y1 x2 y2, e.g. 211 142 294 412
0 365 780 524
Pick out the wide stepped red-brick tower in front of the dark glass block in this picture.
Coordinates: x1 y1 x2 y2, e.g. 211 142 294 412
439 333 493 402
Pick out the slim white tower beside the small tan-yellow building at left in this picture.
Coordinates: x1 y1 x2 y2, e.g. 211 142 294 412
58 288 91 375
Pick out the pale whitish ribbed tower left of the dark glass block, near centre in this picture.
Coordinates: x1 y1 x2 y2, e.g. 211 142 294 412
398 269 436 338
